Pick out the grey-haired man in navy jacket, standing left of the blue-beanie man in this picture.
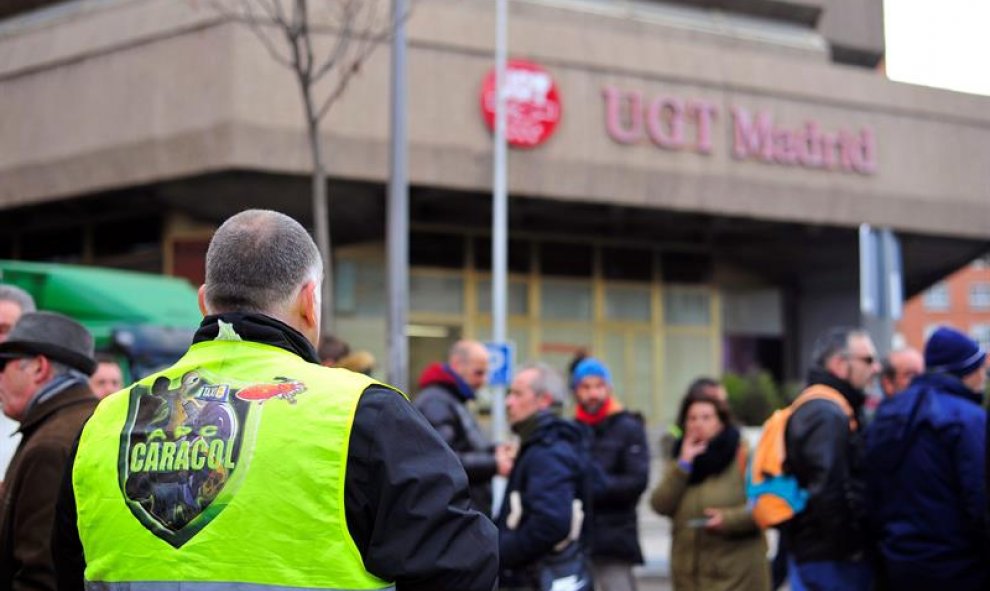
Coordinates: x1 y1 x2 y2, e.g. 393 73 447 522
497 363 592 591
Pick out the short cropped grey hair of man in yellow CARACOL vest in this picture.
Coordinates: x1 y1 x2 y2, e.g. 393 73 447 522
206 209 323 313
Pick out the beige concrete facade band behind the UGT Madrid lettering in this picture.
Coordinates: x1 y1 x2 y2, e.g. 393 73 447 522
0 0 990 237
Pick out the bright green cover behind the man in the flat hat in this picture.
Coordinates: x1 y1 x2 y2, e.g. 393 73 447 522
0 260 202 348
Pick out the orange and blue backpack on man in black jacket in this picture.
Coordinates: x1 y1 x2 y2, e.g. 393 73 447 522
746 384 858 529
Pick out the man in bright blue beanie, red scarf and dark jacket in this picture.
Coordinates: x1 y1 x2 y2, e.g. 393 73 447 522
571 357 650 591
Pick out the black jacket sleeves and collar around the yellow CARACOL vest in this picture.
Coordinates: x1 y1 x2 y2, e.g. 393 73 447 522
53 315 498 591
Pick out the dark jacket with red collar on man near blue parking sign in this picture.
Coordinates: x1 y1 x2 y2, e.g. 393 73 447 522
414 363 497 515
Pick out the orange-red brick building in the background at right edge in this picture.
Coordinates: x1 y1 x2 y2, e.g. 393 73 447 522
898 254 990 349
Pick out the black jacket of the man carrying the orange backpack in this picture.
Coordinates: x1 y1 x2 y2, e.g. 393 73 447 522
781 370 866 562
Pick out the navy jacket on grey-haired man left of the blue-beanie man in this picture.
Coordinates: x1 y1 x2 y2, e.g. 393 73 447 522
497 412 591 587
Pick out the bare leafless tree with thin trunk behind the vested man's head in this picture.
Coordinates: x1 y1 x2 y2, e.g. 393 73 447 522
210 0 408 331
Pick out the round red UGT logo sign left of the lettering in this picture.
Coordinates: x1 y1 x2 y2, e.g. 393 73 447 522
481 60 560 148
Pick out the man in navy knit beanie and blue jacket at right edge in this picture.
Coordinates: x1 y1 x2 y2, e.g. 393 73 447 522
866 328 990 591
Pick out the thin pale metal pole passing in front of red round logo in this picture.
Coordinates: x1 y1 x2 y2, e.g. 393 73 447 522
492 0 509 513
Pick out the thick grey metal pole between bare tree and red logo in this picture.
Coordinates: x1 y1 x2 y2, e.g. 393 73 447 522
386 0 409 391
